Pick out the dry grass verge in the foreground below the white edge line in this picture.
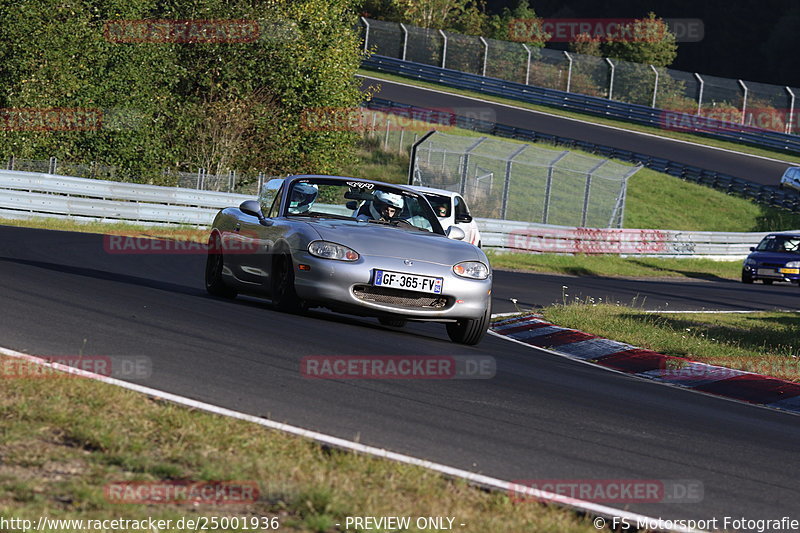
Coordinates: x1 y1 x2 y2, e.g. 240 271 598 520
0 357 595 533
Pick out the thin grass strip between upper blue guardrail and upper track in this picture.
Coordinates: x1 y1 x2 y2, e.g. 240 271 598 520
358 69 800 164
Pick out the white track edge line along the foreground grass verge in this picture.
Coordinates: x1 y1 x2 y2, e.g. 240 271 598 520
0 346 698 533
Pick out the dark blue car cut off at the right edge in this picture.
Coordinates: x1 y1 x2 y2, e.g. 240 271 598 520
742 232 800 285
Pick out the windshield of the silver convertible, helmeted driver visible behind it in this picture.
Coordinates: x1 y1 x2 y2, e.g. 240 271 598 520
283 177 444 234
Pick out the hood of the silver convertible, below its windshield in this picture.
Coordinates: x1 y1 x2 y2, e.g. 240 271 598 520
308 219 483 265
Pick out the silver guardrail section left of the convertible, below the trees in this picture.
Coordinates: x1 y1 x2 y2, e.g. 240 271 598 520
0 170 252 222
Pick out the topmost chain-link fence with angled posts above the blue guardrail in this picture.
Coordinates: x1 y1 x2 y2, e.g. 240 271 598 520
361 18 800 134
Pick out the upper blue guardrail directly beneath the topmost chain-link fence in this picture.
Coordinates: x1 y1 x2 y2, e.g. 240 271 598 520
362 55 800 153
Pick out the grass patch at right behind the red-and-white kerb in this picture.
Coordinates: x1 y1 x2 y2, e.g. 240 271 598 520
538 302 800 381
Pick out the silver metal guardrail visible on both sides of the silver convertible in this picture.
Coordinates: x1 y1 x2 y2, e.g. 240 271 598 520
0 170 766 259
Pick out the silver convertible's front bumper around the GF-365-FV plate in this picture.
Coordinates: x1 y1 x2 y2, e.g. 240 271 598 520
294 251 492 320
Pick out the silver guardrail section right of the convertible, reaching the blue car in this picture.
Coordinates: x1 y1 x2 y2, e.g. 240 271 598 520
475 218 768 260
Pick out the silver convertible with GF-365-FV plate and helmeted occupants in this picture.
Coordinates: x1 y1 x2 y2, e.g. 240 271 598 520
206 175 492 344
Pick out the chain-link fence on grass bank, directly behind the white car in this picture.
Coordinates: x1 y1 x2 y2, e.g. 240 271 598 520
412 132 642 228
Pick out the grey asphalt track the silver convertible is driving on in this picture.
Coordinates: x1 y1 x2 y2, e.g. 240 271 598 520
0 226 800 519
